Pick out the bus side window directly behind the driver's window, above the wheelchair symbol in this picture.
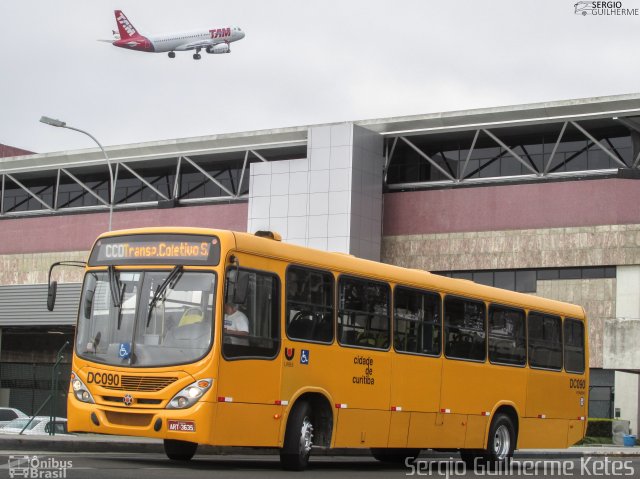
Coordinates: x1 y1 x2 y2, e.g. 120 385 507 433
285 266 334 343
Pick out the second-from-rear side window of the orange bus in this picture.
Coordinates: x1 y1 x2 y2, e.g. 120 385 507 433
528 312 562 371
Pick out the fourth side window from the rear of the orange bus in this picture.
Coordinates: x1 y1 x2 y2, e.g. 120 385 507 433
444 296 486 361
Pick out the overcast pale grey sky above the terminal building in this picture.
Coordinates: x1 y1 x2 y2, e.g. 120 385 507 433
0 0 640 153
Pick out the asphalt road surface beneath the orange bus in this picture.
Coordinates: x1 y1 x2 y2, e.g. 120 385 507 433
0 451 640 479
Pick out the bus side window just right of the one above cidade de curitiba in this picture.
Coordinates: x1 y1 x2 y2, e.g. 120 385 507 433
393 286 441 356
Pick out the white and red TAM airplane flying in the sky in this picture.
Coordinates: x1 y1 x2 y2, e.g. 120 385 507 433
102 10 244 60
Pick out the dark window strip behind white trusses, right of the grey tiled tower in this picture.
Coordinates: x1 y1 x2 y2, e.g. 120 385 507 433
386 119 635 185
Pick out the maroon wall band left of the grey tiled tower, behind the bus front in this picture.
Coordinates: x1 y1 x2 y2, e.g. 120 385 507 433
0 203 248 254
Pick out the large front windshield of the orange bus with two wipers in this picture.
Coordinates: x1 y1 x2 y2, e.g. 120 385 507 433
76 266 216 367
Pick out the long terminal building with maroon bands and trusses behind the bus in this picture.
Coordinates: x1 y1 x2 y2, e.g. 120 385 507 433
0 94 640 433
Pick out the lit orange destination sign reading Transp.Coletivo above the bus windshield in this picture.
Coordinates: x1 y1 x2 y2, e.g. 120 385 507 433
89 234 220 266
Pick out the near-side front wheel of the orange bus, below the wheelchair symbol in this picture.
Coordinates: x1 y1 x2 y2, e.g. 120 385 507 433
280 401 313 471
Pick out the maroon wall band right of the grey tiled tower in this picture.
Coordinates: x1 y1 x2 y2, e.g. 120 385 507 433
383 178 640 236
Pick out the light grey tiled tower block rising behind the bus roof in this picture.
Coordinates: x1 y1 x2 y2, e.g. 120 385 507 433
247 123 384 261
